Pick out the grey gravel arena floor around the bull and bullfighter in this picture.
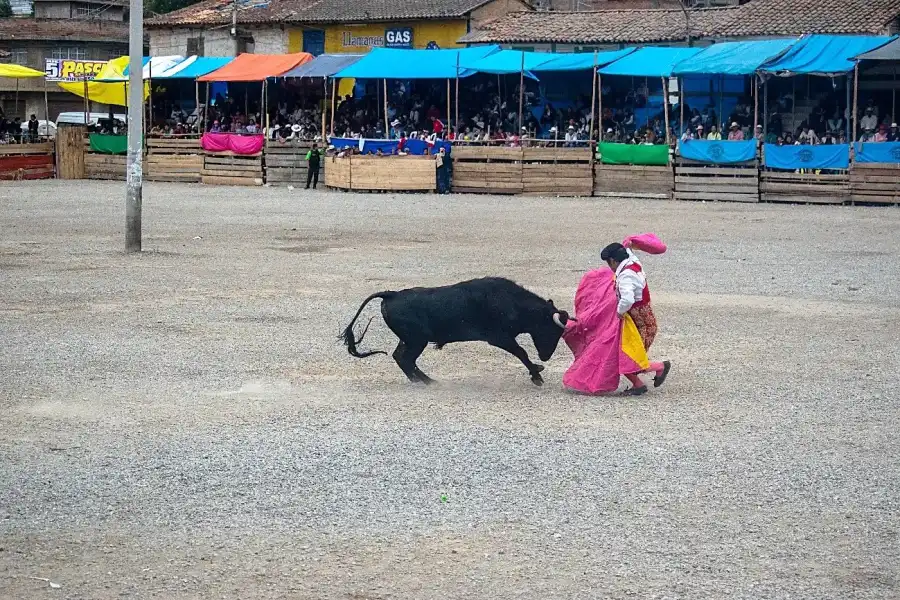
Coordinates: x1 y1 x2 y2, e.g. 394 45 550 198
0 181 900 600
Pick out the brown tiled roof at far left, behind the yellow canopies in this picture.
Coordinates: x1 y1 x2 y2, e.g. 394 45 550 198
0 17 128 43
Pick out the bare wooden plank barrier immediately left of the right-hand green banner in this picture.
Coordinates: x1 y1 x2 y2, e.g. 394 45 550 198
522 147 594 197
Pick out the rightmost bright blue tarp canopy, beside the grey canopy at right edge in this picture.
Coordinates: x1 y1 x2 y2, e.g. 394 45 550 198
761 35 893 76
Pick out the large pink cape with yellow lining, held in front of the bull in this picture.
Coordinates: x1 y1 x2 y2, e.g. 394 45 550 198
563 267 647 394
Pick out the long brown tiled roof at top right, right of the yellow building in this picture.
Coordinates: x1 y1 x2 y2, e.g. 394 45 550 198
460 0 900 43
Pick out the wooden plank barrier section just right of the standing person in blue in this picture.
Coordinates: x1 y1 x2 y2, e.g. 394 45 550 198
450 146 525 194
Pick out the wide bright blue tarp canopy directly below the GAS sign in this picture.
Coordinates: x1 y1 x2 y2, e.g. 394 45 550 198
334 46 500 79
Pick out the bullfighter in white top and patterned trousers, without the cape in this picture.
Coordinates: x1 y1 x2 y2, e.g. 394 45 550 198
600 243 672 396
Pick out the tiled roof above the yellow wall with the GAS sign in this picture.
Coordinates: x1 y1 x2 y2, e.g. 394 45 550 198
146 0 496 27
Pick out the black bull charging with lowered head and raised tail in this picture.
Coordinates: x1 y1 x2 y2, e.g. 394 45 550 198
342 277 574 385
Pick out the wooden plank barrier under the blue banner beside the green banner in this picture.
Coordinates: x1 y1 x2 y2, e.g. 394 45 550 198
675 158 759 202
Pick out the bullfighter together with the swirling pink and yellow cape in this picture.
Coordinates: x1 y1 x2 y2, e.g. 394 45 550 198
563 233 671 396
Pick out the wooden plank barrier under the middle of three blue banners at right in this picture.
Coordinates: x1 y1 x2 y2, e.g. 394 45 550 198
759 170 850 204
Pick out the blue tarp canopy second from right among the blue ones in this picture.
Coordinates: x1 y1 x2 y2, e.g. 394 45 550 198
672 39 797 75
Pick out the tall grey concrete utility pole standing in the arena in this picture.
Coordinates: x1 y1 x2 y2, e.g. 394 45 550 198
125 0 144 252
